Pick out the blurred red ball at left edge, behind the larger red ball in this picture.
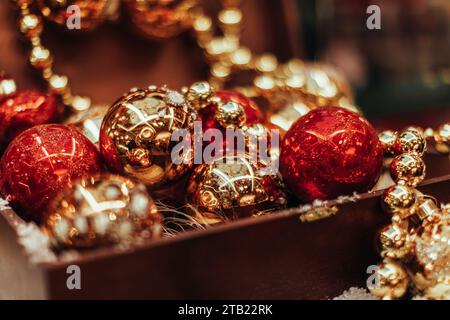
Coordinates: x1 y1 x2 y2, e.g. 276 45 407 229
0 90 62 152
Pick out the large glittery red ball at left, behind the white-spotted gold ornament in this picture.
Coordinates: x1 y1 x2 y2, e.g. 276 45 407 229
0 124 101 222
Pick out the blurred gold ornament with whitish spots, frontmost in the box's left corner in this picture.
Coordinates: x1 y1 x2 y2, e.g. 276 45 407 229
43 174 162 248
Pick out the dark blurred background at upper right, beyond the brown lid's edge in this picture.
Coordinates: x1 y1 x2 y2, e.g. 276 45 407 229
297 0 450 120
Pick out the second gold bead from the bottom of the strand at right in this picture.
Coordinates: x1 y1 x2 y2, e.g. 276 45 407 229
379 224 412 259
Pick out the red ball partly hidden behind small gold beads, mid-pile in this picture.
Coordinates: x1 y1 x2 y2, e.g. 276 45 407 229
198 90 265 132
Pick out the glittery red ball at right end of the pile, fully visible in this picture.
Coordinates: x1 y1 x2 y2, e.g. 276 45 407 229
280 107 383 202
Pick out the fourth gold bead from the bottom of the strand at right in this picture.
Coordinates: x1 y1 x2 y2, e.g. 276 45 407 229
390 153 426 187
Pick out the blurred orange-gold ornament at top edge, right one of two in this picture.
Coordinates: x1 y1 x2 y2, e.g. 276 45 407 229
125 0 198 39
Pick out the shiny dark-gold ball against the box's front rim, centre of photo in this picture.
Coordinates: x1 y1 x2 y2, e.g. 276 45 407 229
186 156 287 225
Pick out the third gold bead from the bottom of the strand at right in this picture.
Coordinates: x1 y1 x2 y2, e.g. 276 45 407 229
382 185 416 219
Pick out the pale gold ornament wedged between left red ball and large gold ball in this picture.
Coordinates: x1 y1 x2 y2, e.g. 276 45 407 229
64 106 108 145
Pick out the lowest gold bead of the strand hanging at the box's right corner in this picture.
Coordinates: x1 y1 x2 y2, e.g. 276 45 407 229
369 259 409 300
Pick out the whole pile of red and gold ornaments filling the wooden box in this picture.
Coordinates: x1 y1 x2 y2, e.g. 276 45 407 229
0 74 383 248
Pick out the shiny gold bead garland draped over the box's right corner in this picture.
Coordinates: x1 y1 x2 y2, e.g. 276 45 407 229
369 124 450 299
